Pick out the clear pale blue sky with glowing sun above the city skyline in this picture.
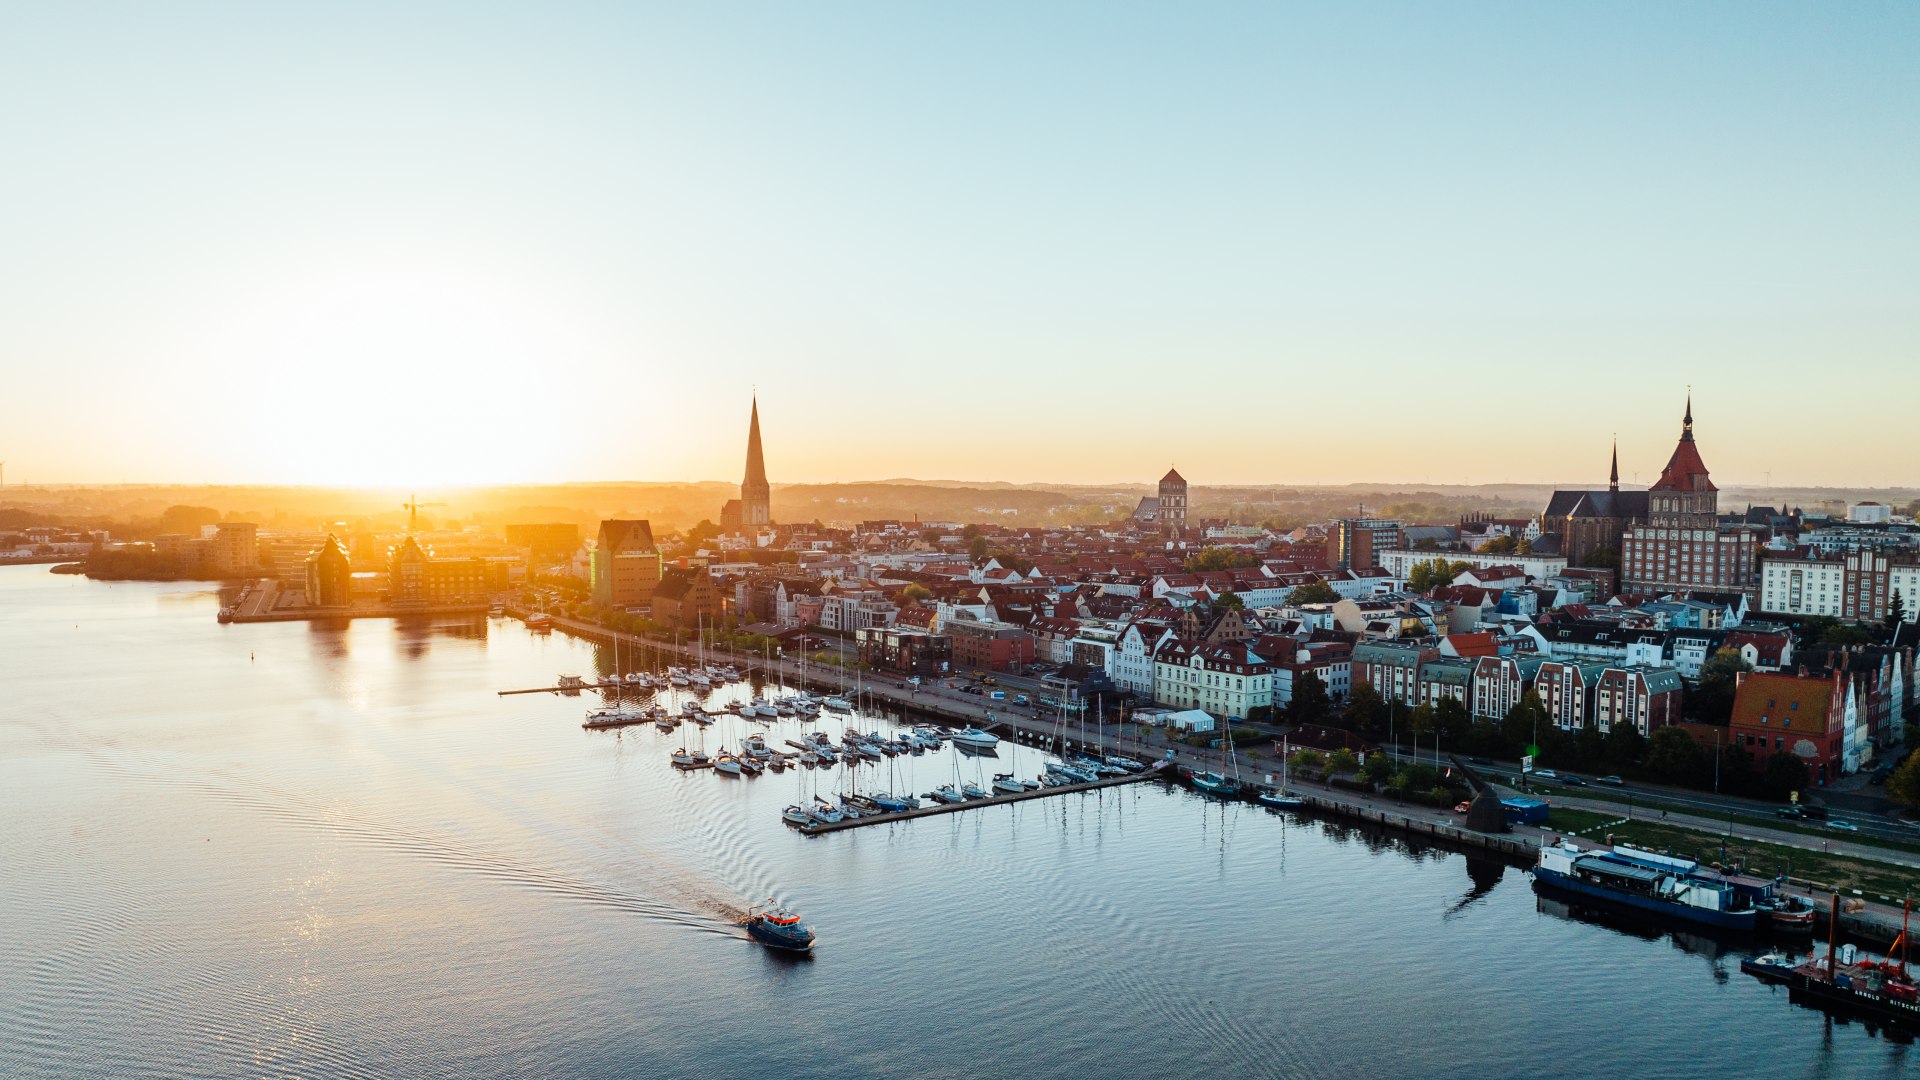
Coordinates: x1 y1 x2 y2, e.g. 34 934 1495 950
0 0 1920 488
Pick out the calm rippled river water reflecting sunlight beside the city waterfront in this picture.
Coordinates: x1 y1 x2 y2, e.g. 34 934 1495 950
0 567 1910 1078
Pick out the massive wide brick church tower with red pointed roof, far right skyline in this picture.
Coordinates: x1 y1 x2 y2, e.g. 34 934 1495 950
1620 396 1755 594
